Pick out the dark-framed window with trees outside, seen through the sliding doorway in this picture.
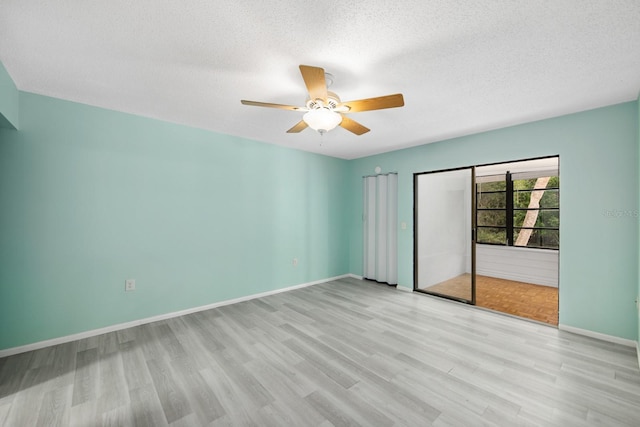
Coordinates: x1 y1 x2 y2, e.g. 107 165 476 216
476 171 560 249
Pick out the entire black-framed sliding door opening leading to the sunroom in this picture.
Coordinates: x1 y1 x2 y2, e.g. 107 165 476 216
414 156 560 326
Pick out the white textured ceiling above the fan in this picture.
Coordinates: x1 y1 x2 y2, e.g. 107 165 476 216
0 0 640 159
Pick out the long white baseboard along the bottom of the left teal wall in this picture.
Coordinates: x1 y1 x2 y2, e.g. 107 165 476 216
0 274 352 358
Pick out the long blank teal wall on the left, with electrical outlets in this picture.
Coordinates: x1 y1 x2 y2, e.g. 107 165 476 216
0 92 349 349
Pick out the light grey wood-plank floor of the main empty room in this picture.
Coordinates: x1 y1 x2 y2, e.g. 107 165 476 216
0 279 640 427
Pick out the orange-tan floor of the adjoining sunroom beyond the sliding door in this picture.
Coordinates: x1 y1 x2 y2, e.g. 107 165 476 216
424 274 558 326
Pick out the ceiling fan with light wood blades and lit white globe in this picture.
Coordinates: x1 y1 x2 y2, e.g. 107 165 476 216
240 65 404 135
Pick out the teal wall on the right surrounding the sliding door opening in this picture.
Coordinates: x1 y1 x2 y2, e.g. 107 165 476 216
349 102 640 340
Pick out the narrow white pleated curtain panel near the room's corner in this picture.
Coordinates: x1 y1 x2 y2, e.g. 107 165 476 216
362 174 398 285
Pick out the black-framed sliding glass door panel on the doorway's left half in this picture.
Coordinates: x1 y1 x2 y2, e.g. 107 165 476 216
414 167 475 304
